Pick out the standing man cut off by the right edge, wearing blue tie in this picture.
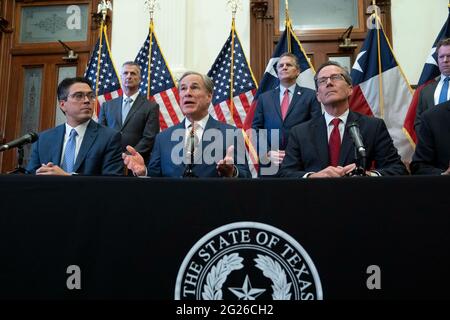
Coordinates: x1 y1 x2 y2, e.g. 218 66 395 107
414 38 450 132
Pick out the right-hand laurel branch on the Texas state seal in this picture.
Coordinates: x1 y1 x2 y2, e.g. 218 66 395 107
254 254 292 300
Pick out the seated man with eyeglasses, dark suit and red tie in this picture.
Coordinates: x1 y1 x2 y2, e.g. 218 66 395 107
280 61 408 178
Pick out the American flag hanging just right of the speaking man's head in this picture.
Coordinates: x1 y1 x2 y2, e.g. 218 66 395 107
208 28 257 128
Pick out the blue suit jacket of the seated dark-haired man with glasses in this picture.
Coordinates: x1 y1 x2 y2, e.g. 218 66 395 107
27 120 123 176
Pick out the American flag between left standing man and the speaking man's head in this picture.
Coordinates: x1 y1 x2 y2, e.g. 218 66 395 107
134 22 184 130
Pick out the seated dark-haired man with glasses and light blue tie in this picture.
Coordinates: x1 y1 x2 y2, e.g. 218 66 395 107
27 77 123 176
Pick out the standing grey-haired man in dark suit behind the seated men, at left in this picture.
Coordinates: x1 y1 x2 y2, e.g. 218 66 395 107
99 61 159 163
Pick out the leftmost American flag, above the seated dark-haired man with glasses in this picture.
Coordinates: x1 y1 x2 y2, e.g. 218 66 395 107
84 26 122 118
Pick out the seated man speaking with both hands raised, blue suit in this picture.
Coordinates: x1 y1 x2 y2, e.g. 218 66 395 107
122 72 251 178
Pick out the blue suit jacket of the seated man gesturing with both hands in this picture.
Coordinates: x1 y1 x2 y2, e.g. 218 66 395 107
147 117 251 178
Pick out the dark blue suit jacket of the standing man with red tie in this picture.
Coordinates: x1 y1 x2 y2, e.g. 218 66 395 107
252 85 322 150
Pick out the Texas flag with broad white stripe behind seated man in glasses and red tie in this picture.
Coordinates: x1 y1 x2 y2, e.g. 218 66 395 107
350 18 414 162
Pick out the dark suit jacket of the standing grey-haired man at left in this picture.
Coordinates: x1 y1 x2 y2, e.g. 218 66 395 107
99 94 159 163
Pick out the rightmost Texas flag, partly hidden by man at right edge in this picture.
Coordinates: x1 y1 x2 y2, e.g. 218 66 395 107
404 4 450 143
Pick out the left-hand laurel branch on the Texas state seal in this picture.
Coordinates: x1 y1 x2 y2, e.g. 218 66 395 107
202 253 244 300
